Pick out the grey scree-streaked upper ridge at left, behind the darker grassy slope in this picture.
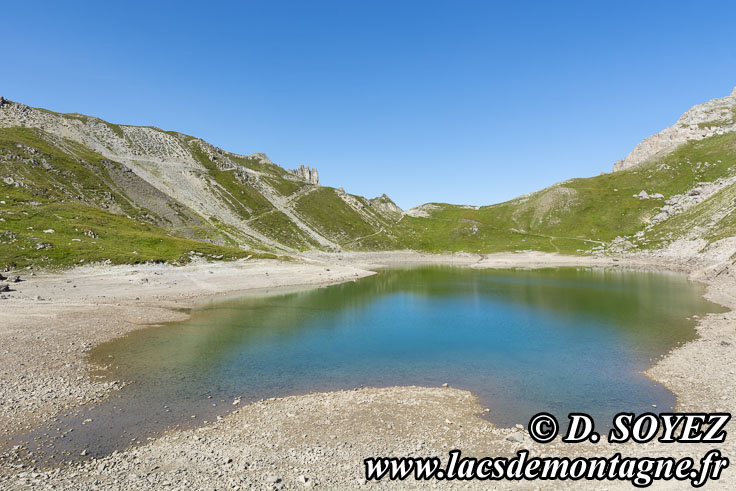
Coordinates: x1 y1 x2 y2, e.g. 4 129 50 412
0 99 402 266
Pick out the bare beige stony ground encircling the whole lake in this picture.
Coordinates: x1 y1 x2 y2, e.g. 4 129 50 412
0 252 736 489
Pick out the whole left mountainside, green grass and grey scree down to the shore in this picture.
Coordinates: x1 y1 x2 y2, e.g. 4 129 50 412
0 100 401 264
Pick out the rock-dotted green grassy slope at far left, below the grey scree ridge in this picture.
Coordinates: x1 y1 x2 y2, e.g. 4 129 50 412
0 128 268 268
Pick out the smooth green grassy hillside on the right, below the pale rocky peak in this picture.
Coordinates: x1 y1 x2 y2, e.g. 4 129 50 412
397 133 736 254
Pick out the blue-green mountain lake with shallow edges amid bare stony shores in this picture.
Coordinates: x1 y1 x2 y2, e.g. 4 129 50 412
11 267 720 456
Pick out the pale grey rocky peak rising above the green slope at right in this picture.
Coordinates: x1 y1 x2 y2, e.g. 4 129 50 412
613 88 736 172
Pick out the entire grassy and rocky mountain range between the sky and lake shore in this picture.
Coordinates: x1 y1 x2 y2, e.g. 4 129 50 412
0 90 736 265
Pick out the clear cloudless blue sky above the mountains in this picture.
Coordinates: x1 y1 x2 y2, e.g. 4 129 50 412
0 0 736 208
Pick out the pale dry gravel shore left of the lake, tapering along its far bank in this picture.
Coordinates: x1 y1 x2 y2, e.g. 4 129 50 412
0 260 372 436
